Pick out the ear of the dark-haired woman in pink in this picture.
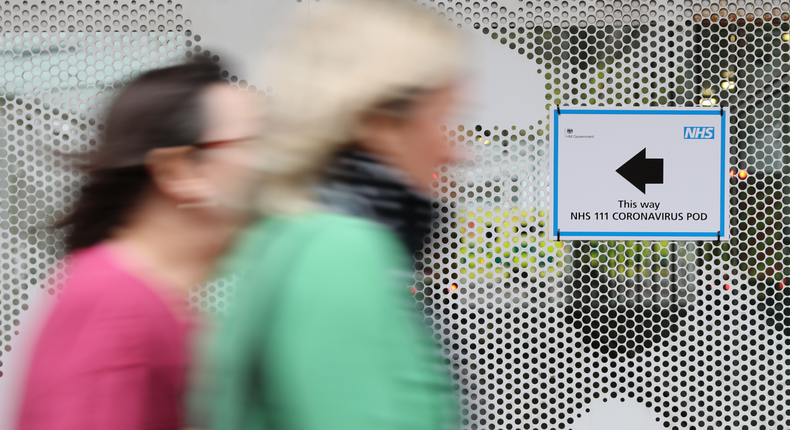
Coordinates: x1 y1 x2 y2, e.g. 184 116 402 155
145 146 213 205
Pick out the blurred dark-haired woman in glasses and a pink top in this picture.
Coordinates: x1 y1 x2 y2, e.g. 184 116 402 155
19 59 259 430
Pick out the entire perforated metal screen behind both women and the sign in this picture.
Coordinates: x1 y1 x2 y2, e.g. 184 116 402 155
0 0 790 430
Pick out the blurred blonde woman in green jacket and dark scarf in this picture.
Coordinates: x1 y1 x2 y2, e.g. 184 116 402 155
214 0 468 430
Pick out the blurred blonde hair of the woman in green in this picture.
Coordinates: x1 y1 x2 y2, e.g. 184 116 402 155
256 0 461 214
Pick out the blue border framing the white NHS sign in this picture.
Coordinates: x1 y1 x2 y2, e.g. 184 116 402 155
552 106 728 238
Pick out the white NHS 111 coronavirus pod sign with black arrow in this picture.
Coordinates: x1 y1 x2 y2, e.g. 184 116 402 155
549 107 729 240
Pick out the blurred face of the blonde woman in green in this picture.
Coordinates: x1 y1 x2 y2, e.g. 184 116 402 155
363 85 458 192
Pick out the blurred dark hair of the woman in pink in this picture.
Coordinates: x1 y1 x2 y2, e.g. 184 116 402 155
55 56 223 252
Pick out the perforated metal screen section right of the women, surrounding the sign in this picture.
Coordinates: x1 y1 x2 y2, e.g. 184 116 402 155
416 1 790 429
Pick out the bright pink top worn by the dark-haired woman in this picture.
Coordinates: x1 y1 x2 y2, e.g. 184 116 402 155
18 245 189 430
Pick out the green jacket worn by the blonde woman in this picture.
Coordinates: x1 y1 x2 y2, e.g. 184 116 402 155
207 212 457 430
